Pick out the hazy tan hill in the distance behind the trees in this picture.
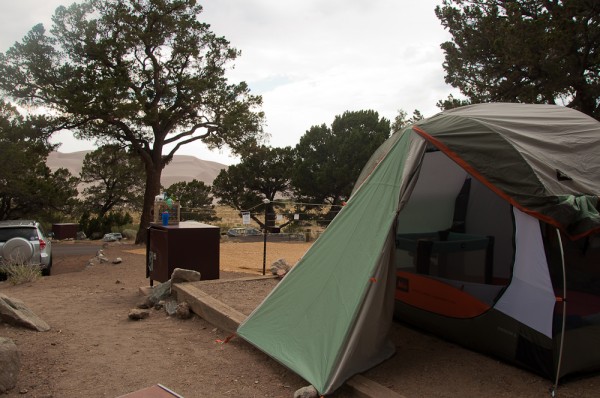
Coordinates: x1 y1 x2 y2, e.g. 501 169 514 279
46 151 227 188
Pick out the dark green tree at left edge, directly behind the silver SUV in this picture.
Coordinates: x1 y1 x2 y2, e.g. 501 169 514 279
0 101 78 220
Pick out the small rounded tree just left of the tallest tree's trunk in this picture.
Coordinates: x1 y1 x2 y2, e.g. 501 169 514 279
80 145 144 218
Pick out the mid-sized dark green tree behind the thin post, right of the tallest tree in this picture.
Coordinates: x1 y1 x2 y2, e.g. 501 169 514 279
212 146 294 228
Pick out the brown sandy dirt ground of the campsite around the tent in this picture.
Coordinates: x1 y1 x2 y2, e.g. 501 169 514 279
0 238 600 398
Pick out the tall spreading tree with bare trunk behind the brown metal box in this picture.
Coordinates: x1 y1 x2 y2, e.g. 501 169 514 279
0 0 264 241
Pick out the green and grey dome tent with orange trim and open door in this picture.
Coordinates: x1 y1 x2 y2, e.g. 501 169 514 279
238 104 600 394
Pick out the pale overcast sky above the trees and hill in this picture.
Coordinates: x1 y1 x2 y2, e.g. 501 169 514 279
0 0 456 164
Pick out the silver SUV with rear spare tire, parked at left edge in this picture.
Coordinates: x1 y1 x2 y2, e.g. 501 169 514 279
0 220 52 275
